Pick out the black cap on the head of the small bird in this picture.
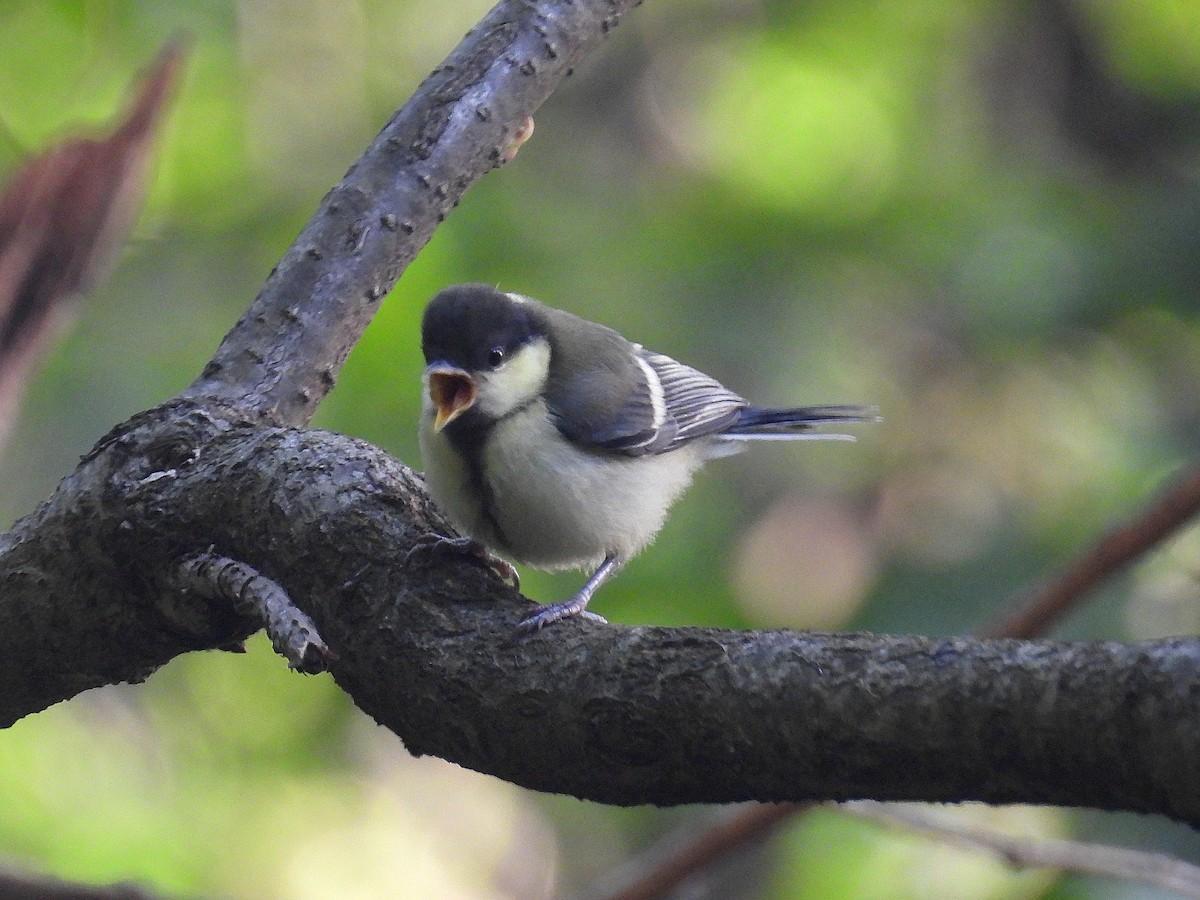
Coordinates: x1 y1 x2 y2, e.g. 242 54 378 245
421 284 545 372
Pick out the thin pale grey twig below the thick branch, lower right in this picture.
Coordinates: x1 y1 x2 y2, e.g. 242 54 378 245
839 800 1200 898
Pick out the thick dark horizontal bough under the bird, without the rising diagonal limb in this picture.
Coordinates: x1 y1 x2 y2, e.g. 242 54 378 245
0 422 1200 823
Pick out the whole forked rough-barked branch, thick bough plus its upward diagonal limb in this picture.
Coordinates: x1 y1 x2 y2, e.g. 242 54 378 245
0 0 1200 824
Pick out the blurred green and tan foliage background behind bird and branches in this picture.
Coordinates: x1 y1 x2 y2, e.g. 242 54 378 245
0 0 1200 898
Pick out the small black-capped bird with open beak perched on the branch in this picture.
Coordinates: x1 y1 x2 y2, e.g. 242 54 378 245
419 283 878 632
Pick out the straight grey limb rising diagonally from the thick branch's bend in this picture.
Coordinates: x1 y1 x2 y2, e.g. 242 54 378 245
178 0 637 425
